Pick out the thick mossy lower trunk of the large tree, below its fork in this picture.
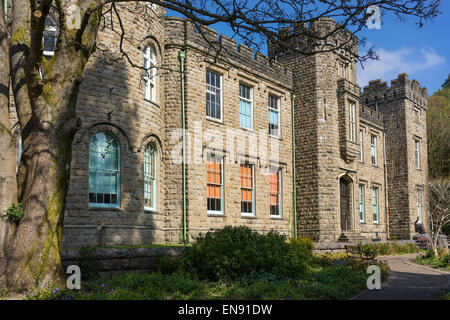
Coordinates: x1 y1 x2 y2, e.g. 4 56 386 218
6 123 72 291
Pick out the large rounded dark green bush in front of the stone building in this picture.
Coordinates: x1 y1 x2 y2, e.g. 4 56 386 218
180 226 311 281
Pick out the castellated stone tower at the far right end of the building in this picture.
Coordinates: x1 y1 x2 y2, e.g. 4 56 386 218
362 73 429 239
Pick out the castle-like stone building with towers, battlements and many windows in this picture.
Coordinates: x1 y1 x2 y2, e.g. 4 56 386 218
10 4 427 248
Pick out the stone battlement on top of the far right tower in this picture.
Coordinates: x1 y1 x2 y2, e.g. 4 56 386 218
362 73 428 107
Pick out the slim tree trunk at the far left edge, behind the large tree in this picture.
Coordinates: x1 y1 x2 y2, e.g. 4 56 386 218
0 3 17 289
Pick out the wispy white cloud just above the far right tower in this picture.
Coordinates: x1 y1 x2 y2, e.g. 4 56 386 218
357 47 445 87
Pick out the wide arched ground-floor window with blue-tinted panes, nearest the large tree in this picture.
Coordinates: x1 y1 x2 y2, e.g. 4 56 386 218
89 132 120 207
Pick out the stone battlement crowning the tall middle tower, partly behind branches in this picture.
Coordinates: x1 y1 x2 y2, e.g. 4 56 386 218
267 18 358 60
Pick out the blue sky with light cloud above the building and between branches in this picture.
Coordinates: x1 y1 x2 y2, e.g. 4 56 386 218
168 0 450 95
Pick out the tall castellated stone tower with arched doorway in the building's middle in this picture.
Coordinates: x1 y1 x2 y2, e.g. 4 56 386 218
268 18 360 242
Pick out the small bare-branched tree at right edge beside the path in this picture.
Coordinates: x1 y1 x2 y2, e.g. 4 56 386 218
425 179 450 256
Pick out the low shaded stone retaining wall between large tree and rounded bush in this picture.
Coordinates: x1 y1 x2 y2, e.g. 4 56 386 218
61 246 184 275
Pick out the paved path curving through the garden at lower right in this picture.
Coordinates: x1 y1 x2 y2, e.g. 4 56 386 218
352 254 450 300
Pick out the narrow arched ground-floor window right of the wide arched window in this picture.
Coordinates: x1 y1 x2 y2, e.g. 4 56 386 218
144 143 156 210
